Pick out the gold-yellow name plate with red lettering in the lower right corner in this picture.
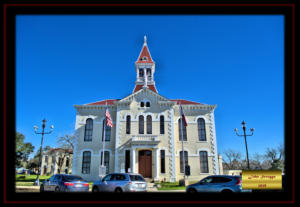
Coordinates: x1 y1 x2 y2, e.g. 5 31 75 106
242 170 282 189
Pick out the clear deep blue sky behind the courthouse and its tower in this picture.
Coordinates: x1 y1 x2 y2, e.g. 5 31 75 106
16 15 284 160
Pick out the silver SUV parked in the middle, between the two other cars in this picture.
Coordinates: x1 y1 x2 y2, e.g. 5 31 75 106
92 173 147 193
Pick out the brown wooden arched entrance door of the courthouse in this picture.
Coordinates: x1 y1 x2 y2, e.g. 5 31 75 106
139 150 152 178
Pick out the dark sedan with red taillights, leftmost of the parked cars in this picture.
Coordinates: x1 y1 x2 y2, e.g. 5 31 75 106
40 174 89 192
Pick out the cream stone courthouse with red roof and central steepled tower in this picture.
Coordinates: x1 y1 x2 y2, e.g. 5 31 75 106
72 37 222 181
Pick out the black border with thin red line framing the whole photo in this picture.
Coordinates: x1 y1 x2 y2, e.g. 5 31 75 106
2 3 296 204
